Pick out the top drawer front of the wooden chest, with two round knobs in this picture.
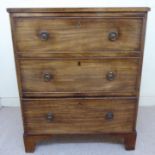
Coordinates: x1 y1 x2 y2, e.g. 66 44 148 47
15 17 143 53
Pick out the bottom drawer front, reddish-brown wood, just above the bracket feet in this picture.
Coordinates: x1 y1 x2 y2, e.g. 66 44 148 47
22 98 137 134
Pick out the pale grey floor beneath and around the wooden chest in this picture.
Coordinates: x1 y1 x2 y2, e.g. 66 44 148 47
0 107 155 155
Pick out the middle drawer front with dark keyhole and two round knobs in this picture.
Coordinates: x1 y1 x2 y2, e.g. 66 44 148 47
20 59 139 97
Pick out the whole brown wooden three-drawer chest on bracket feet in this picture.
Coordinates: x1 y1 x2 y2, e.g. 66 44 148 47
8 8 149 152
